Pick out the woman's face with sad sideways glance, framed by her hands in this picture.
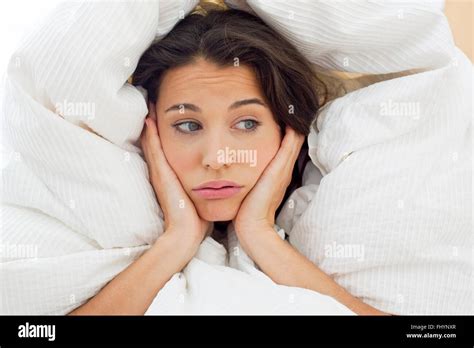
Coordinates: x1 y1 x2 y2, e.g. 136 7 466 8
156 59 281 221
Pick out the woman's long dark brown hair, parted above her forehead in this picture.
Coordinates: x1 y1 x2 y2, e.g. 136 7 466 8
133 10 319 223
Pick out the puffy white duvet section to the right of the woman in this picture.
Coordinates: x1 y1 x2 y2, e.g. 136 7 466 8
228 0 473 314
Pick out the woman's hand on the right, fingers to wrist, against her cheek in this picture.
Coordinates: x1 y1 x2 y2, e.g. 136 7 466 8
232 126 305 239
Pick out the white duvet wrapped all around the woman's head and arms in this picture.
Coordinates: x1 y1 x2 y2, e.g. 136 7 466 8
0 1 473 314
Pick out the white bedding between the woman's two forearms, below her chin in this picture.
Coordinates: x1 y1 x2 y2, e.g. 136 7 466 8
146 224 353 315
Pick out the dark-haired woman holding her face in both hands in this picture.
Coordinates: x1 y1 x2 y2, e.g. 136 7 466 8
72 10 384 314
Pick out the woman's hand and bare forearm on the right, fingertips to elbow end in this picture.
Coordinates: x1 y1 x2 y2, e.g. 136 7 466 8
232 127 388 315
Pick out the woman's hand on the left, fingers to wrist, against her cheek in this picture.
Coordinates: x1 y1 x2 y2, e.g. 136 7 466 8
141 103 210 257
